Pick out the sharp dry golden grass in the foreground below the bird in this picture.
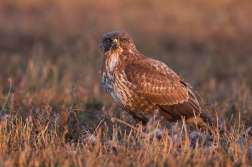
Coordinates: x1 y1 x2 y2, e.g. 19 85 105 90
0 103 251 166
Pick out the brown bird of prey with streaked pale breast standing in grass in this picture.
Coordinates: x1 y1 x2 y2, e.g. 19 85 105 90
99 30 213 129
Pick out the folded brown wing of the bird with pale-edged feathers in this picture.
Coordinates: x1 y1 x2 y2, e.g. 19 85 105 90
124 57 201 119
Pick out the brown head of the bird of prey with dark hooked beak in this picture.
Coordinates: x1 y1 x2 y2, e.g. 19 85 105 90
99 30 136 55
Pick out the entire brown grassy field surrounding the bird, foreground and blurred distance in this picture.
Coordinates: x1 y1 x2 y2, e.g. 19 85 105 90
0 0 252 167
